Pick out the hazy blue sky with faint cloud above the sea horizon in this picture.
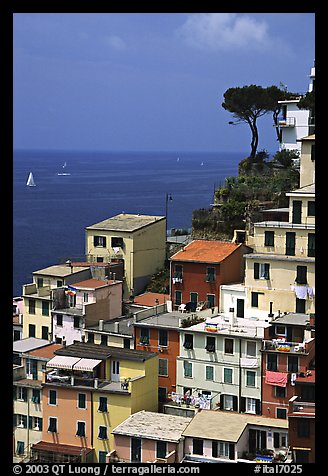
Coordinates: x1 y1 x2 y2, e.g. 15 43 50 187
14 13 315 152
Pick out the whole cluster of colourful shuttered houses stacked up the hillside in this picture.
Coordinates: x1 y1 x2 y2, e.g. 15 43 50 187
13 67 315 463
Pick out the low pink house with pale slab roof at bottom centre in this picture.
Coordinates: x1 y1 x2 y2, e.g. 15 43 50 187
108 410 192 463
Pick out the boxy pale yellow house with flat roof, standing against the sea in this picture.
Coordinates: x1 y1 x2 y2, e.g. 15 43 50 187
85 213 166 298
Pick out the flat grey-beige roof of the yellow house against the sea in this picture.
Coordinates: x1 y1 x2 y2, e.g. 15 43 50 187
86 213 165 232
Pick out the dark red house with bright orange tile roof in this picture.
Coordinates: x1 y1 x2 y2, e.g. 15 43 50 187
170 240 250 310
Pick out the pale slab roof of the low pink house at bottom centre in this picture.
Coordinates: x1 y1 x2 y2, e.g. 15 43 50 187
112 410 192 443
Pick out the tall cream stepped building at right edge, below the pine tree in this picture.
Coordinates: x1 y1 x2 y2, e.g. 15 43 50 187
245 135 315 319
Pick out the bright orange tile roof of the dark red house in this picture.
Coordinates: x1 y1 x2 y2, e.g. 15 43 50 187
170 240 241 263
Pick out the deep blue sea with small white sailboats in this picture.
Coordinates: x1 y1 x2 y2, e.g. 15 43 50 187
13 150 247 296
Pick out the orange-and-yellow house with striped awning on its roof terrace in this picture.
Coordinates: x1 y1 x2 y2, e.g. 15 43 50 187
42 342 158 462
